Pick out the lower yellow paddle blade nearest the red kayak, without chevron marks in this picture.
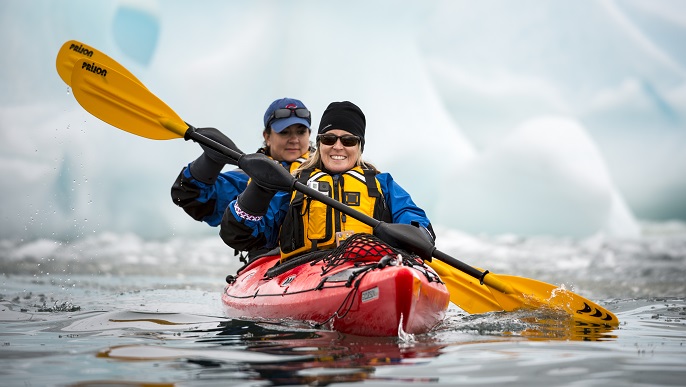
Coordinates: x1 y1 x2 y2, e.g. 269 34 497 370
427 259 504 314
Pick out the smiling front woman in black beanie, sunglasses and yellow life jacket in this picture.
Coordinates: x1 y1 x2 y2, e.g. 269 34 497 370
219 101 435 260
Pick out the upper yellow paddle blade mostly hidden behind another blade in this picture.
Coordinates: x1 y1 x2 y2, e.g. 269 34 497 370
55 40 145 87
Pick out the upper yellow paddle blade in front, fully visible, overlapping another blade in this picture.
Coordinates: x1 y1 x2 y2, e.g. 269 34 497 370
71 59 189 140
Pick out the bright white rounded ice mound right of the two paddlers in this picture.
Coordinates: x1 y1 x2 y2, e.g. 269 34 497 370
437 117 639 237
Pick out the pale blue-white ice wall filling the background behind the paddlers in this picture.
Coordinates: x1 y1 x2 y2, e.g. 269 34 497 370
0 0 686 240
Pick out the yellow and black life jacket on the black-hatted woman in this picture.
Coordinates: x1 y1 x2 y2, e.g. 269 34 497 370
279 167 392 261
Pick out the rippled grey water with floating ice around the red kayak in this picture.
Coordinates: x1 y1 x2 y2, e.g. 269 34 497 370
0 228 686 386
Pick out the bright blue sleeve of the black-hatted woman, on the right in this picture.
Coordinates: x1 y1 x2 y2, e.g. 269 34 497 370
376 173 431 228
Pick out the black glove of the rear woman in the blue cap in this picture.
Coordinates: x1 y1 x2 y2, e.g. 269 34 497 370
190 128 243 184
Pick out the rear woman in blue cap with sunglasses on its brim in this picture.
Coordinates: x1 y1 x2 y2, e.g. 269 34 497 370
171 98 313 258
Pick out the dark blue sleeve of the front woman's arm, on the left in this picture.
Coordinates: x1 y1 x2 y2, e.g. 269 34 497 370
229 191 291 248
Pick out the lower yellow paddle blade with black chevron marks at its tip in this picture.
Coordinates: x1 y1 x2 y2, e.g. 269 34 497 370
484 273 619 327
